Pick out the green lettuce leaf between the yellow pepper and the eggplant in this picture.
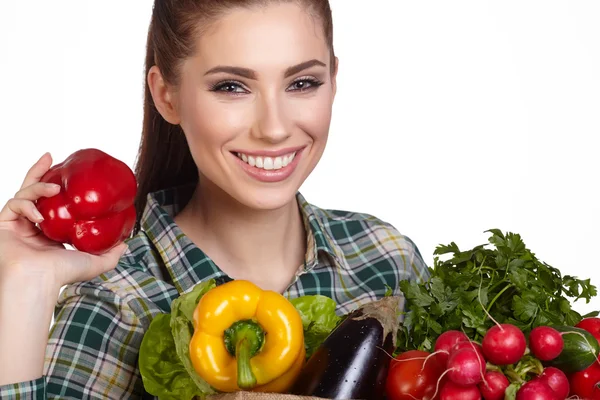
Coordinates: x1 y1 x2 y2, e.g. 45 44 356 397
290 295 342 358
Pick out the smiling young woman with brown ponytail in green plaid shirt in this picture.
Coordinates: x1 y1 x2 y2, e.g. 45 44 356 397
0 0 427 399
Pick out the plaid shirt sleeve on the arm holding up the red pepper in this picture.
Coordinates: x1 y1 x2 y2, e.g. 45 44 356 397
0 282 144 399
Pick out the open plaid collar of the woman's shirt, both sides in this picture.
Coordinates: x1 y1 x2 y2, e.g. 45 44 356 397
141 185 339 294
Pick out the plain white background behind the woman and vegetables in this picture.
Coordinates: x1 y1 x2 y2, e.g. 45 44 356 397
0 0 600 312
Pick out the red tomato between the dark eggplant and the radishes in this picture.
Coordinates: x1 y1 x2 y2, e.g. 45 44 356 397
386 350 443 400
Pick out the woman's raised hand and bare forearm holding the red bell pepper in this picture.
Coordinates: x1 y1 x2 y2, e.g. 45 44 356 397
0 154 127 385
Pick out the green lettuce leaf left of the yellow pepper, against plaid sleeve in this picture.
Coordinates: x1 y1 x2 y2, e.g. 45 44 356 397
139 314 204 400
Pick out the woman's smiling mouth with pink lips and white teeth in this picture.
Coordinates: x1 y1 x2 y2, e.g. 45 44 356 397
231 147 304 183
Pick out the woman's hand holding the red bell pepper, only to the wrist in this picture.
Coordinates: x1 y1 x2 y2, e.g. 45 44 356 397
0 153 126 288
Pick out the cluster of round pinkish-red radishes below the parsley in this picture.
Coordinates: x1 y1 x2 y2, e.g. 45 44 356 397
426 324 569 400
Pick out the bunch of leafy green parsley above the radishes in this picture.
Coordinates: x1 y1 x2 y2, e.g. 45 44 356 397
396 229 598 352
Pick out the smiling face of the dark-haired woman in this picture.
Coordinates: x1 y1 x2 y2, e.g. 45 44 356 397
174 4 336 210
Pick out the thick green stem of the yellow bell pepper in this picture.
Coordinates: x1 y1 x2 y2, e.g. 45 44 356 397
224 320 265 389
